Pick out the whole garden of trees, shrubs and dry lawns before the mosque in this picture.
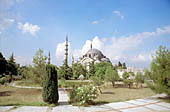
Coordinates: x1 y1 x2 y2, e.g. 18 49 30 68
0 47 170 106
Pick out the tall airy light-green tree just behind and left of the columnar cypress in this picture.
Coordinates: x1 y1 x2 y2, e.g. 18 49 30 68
32 49 47 85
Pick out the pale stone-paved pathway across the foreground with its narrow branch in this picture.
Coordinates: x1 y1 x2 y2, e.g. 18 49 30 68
0 82 170 112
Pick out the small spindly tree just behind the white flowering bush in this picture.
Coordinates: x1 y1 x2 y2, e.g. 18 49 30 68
91 76 104 94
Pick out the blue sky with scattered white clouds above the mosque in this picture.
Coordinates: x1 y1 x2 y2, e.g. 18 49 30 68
0 0 170 68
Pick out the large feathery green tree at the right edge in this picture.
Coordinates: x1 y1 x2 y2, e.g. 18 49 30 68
149 46 170 96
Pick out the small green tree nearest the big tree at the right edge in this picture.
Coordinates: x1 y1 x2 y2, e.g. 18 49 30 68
135 72 144 87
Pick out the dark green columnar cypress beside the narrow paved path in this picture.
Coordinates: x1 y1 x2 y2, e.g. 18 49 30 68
42 65 59 104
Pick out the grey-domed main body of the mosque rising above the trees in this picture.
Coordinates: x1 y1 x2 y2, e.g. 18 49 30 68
78 44 110 70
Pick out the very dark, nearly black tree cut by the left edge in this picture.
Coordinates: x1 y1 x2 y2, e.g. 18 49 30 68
0 52 7 75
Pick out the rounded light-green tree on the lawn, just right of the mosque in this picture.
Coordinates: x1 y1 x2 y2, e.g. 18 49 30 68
105 67 119 87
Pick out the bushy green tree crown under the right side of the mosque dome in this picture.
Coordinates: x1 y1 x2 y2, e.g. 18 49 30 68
95 62 113 80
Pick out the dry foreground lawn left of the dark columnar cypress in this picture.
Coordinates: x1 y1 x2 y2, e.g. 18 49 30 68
0 85 49 106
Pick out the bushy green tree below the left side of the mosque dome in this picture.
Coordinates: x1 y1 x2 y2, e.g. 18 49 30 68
71 63 87 79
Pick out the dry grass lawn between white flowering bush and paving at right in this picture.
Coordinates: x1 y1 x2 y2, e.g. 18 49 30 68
95 85 155 103
